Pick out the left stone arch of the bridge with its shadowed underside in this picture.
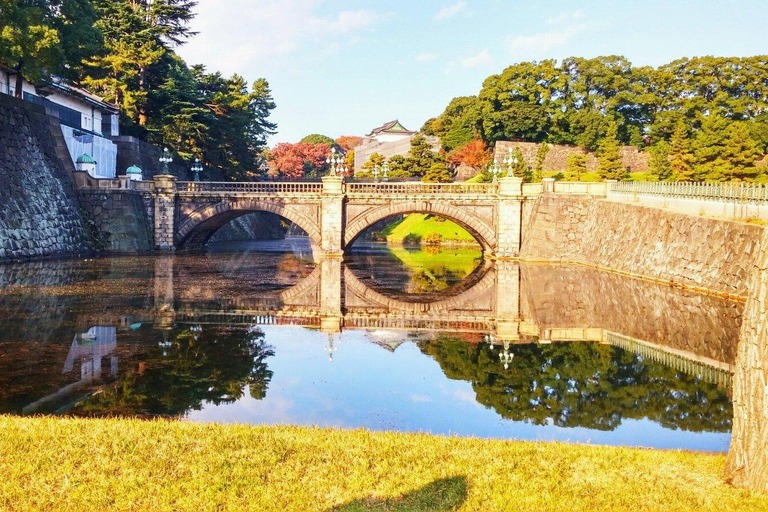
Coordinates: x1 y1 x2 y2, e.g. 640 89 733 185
176 198 320 247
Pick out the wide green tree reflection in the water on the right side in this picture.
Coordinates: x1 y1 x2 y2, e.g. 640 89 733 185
420 336 732 432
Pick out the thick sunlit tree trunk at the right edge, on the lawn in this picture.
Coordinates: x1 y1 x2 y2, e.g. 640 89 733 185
725 229 768 492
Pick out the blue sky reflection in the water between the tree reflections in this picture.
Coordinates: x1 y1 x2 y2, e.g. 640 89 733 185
188 326 730 451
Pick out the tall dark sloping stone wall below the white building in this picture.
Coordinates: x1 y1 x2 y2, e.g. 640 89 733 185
0 94 99 261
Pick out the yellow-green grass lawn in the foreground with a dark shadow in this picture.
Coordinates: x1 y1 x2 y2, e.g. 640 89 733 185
0 416 768 512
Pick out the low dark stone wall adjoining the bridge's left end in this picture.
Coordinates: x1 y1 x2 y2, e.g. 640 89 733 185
80 190 154 252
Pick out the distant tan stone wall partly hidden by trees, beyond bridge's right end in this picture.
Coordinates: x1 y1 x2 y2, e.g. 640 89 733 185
493 141 650 172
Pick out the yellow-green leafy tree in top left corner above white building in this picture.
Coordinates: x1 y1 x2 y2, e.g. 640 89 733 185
0 0 100 98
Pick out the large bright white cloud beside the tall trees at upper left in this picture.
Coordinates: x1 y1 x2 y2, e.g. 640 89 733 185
179 0 384 74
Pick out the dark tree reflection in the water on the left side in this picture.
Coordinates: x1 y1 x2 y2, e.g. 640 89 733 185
71 326 274 416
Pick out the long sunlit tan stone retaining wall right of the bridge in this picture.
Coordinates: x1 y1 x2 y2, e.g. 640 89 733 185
521 194 763 298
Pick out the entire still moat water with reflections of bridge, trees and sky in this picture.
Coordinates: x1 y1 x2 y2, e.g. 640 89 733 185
0 238 743 451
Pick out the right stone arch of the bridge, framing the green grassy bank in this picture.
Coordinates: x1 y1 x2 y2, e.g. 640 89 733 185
344 200 496 252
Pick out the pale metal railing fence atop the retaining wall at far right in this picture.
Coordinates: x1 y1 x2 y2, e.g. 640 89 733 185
609 181 768 204
